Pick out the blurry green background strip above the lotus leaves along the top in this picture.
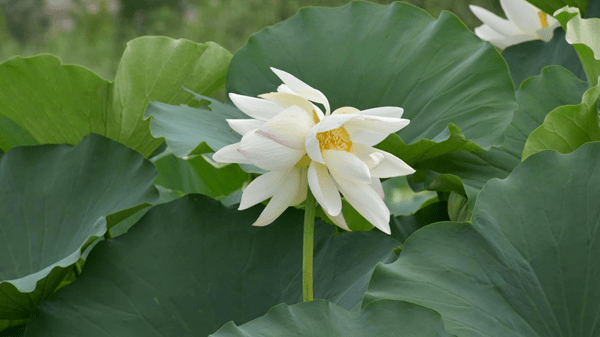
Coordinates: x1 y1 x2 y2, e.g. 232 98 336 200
0 0 502 80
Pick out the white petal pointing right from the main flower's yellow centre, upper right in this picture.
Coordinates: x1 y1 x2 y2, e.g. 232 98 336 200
344 116 410 145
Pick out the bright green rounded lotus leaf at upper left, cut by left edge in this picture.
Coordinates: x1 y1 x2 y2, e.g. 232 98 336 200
0 54 111 144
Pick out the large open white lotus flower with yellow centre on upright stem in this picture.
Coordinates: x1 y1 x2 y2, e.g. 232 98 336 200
213 68 414 234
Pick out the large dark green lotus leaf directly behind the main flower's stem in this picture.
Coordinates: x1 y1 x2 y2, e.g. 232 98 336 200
21 195 400 337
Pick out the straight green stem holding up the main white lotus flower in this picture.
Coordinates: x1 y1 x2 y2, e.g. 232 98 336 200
302 189 317 302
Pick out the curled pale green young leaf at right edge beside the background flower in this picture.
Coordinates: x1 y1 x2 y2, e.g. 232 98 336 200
554 7 600 86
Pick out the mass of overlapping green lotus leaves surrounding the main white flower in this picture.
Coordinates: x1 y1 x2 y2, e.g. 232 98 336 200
0 0 600 337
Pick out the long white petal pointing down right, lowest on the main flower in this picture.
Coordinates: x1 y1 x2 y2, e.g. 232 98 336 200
334 176 391 234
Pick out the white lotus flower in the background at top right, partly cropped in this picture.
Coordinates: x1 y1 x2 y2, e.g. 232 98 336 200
469 0 560 49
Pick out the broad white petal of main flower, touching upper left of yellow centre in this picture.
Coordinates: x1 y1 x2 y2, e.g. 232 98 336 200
258 105 314 151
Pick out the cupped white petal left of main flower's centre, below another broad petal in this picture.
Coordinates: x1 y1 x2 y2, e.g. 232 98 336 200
238 131 304 171
